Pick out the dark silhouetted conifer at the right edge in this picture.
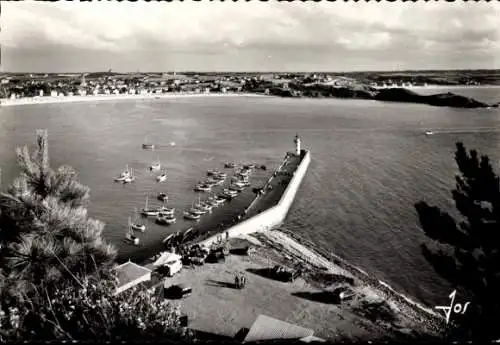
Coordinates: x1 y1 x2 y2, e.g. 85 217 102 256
415 143 500 340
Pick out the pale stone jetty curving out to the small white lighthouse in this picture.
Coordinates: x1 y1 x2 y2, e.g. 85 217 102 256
198 150 311 246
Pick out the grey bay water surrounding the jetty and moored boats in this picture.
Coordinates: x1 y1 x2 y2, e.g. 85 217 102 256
0 89 500 306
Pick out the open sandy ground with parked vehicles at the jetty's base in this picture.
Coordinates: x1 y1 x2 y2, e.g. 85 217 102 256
154 230 441 341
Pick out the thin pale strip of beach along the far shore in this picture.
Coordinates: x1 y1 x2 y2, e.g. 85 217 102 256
0 92 264 107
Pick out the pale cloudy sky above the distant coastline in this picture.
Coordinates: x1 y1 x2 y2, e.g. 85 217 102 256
0 0 500 73
